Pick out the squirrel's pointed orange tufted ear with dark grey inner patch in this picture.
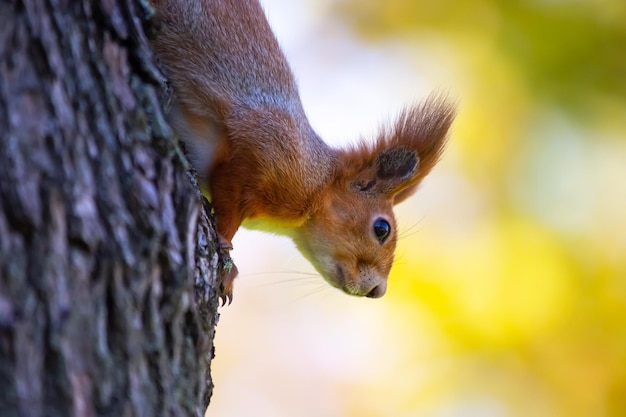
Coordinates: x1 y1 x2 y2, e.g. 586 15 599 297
348 96 455 204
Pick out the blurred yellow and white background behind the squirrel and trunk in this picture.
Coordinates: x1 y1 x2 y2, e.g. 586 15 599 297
207 0 626 417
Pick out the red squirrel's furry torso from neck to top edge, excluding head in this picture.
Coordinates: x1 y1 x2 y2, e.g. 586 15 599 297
153 0 335 223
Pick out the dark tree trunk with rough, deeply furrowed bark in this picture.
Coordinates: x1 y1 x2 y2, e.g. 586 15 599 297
0 0 218 417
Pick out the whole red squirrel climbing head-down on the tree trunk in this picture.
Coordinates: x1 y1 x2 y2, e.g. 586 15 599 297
152 0 454 303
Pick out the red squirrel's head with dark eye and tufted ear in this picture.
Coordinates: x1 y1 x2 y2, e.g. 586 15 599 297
294 97 454 298
